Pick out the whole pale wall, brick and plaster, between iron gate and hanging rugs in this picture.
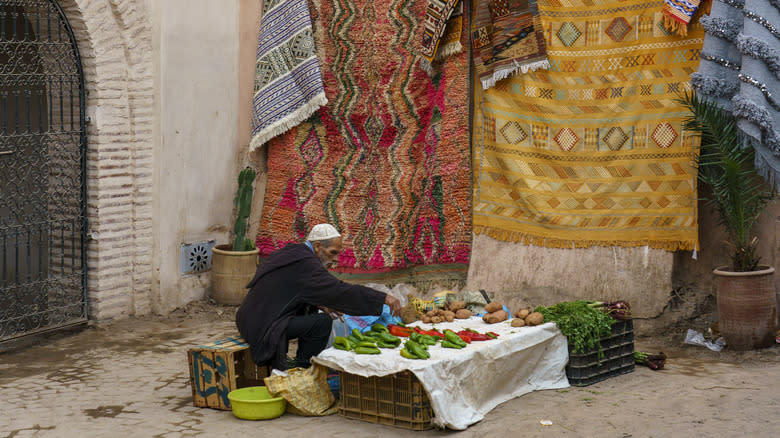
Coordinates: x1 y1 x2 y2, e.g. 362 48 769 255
59 0 260 320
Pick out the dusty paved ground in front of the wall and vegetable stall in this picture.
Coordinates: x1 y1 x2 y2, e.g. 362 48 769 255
0 301 780 438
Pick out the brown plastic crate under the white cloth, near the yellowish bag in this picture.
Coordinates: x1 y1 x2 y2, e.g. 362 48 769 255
339 371 433 430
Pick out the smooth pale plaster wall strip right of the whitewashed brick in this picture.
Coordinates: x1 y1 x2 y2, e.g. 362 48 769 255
155 0 244 313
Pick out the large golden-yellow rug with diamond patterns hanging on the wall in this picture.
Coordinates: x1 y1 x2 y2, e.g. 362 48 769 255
474 0 703 250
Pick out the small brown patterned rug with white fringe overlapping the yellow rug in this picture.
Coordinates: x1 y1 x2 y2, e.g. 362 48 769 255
471 0 550 89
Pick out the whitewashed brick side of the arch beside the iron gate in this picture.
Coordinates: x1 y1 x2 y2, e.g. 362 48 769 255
57 0 159 320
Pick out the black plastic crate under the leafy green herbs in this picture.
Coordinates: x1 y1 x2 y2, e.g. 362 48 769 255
566 319 634 386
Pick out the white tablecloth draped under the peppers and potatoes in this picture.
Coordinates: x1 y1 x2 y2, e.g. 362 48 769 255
312 317 569 430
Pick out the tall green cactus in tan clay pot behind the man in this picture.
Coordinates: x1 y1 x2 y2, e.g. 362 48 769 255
211 167 259 305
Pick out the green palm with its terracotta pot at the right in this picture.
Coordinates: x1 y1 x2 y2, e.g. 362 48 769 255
680 93 777 350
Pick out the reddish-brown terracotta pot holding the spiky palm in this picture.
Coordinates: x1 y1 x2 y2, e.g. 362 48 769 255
712 266 777 350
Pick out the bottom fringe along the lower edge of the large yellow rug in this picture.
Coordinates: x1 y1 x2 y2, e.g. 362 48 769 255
474 225 698 251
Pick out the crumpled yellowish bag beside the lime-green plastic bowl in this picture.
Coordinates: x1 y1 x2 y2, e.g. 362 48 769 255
264 364 338 417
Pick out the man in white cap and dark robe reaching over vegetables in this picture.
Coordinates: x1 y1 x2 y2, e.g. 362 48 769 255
236 224 401 370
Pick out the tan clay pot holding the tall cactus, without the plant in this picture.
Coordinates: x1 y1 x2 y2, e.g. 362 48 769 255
211 245 260 305
